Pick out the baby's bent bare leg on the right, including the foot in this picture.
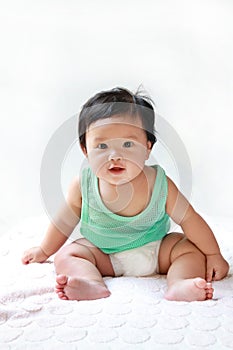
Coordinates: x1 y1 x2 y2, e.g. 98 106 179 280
160 234 213 301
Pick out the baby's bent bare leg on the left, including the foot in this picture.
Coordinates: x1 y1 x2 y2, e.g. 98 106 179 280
55 239 114 300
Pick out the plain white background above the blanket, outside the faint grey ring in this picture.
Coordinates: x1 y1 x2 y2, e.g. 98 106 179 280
0 0 233 232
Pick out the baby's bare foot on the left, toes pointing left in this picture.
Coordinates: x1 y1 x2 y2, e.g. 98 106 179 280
55 275 111 300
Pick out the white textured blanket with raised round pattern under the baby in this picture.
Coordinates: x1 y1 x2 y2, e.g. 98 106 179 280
0 217 233 350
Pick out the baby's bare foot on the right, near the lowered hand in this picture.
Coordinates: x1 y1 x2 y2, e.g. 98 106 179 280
165 277 214 301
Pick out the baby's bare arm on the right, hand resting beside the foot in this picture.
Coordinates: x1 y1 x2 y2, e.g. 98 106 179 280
166 178 229 281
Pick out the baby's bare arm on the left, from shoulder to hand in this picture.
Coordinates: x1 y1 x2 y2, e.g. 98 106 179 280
22 179 82 264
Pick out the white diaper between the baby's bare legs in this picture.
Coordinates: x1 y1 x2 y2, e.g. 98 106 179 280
109 240 161 277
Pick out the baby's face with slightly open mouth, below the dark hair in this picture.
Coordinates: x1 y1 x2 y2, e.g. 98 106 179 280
83 116 151 185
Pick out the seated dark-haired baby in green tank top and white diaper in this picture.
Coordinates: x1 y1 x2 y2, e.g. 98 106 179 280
22 88 229 301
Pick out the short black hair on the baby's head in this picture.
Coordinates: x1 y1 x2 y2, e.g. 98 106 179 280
78 87 156 148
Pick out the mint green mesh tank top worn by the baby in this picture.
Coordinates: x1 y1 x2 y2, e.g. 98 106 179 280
80 165 170 254
